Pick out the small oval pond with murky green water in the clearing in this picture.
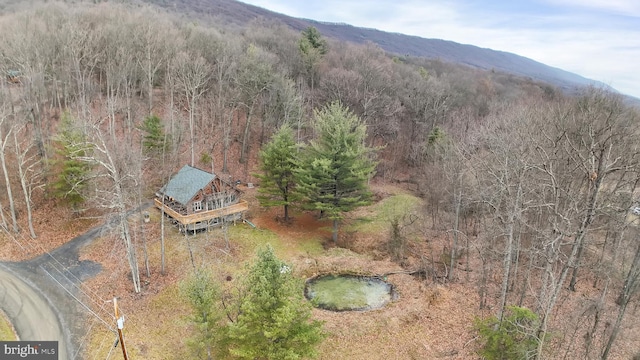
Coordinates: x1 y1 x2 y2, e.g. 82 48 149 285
304 275 395 311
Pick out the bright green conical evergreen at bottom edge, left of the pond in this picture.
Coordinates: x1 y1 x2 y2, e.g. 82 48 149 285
229 246 323 360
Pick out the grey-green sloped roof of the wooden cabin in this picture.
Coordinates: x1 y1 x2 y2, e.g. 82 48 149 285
160 165 216 205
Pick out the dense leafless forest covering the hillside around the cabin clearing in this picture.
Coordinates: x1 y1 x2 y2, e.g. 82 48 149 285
0 3 640 359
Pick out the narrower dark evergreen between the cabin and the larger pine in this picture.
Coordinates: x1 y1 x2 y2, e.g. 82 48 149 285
256 126 299 222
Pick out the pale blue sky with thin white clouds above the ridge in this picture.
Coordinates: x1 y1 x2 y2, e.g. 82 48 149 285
242 0 640 98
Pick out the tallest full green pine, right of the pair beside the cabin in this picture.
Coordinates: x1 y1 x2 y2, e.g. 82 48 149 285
296 102 376 242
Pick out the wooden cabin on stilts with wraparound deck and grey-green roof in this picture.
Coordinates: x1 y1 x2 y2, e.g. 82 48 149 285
154 165 249 232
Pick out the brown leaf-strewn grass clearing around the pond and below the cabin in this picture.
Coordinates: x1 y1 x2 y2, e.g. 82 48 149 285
77 188 477 360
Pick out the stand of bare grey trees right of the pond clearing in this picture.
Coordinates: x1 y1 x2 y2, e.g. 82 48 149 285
425 93 640 359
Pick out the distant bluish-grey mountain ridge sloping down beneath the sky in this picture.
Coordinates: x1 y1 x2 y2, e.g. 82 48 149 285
143 0 609 93
